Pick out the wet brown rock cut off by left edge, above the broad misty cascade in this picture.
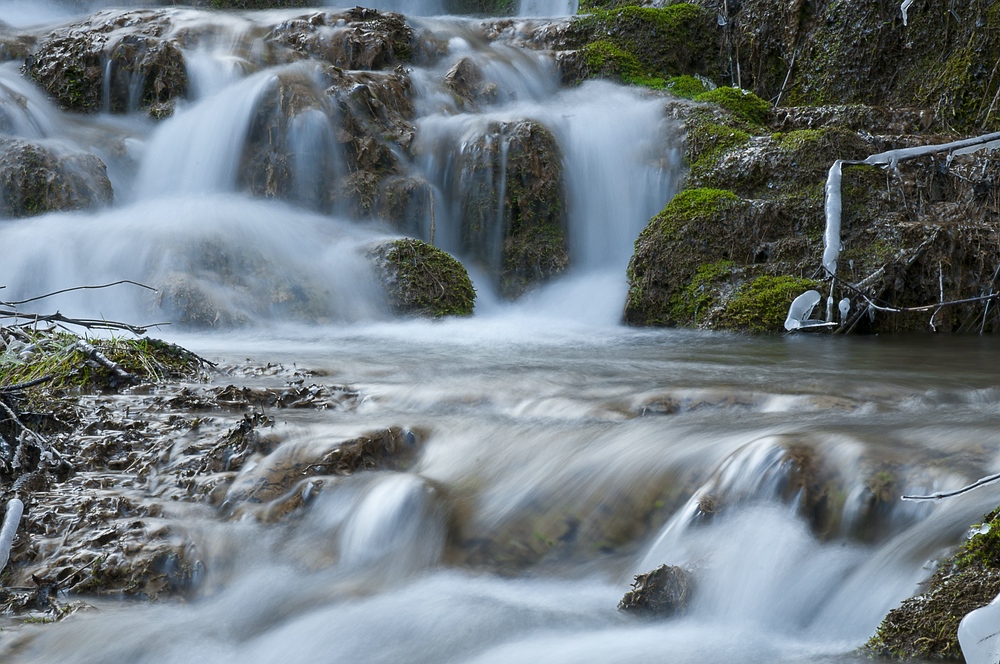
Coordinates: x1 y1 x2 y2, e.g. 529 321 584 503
0 138 114 217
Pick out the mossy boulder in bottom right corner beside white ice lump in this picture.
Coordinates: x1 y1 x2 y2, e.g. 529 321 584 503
865 510 1000 660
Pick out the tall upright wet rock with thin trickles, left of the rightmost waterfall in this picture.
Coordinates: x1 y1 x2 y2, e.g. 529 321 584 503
460 120 569 298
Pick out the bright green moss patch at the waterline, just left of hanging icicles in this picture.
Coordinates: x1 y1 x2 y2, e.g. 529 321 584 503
720 275 820 334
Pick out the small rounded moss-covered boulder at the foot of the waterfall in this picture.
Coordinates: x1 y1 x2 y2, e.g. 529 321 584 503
368 238 476 318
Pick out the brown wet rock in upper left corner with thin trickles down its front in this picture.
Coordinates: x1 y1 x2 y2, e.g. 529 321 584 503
24 10 188 117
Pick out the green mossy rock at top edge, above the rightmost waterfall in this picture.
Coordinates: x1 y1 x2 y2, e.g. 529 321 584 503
567 3 718 87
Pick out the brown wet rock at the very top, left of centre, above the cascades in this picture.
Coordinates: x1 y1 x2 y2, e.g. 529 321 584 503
267 7 413 70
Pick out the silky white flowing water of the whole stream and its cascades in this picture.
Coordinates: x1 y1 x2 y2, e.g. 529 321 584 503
0 2 1000 664
